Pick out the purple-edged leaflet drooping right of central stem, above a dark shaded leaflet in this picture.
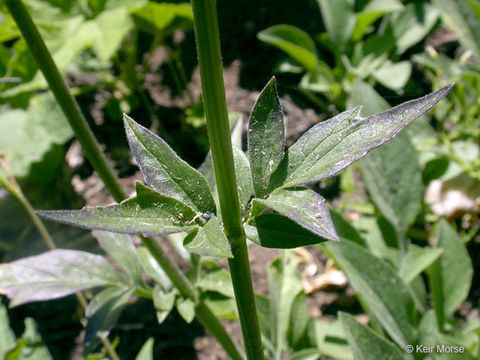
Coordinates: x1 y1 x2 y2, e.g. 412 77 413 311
253 188 338 241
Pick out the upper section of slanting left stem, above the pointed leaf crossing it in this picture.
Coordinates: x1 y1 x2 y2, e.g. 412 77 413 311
5 0 125 201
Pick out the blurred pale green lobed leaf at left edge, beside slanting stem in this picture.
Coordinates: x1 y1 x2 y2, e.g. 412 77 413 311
0 93 73 177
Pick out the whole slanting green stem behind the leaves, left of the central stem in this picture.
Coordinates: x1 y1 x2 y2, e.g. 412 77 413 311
5 0 243 360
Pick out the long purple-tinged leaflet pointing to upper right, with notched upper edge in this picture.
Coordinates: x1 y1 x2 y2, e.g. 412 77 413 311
271 86 452 188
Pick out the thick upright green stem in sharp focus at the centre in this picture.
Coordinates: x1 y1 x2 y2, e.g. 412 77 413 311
192 0 263 360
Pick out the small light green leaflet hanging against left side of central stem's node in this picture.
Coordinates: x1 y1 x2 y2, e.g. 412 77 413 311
183 217 233 258
